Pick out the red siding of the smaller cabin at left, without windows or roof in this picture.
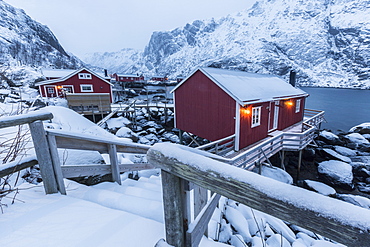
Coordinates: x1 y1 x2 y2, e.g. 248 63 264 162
40 70 112 102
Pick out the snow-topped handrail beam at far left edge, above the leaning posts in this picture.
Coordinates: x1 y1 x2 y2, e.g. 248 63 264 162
0 111 53 129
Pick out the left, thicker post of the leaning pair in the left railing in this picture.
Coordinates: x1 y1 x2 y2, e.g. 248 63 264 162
28 121 58 194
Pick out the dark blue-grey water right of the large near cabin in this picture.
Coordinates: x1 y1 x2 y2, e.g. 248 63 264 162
301 87 370 132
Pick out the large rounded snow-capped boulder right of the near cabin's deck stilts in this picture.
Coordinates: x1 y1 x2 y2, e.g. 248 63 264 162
318 160 353 189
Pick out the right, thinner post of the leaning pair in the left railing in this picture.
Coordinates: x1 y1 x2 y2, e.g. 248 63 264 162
47 135 67 195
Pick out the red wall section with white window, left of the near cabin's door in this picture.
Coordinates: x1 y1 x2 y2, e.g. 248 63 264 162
239 102 270 149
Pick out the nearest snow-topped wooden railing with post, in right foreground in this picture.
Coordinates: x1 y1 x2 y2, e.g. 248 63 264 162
147 143 370 247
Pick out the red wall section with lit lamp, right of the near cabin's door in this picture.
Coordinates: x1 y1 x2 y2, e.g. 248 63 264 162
278 97 305 130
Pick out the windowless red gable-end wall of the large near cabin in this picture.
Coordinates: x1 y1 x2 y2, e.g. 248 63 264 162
175 71 236 141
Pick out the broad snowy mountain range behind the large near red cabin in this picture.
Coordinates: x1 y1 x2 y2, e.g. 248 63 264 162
85 0 370 88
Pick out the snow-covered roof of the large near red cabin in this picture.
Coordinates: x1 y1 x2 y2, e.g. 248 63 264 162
172 68 308 105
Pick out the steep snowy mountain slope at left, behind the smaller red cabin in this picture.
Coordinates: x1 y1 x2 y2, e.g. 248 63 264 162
0 0 83 85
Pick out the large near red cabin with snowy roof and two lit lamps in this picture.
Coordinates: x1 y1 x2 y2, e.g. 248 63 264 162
172 68 308 150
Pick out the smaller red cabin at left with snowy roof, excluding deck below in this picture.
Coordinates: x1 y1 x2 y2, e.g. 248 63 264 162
35 68 112 102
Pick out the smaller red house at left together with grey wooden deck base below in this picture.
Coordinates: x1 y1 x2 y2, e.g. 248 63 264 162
35 68 113 114
